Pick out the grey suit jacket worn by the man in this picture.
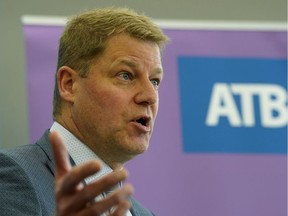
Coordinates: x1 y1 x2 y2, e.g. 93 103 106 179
0 131 153 216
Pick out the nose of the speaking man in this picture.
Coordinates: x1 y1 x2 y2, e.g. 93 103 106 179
135 78 158 105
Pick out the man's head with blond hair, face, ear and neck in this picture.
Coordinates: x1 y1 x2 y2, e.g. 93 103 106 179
54 9 167 167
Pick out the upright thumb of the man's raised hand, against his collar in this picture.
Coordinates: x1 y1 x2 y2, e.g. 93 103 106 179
49 131 71 179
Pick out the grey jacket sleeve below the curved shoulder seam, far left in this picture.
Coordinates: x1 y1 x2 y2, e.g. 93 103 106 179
0 150 41 216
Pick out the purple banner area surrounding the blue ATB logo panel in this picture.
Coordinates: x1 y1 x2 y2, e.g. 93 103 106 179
24 20 287 216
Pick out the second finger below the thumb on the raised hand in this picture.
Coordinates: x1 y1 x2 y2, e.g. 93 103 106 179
64 169 129 212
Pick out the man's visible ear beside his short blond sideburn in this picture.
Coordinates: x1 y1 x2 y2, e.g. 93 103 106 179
57 66 78 103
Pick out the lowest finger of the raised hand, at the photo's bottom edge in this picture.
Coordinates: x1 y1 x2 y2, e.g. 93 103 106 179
80 184 134 216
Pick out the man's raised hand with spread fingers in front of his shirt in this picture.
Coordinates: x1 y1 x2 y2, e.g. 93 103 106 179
49 132 133 216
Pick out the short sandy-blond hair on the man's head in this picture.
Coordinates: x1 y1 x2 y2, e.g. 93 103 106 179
53 8 168 119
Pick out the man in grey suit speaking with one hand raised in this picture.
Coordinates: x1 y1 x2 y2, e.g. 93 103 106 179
0 8 167 216
